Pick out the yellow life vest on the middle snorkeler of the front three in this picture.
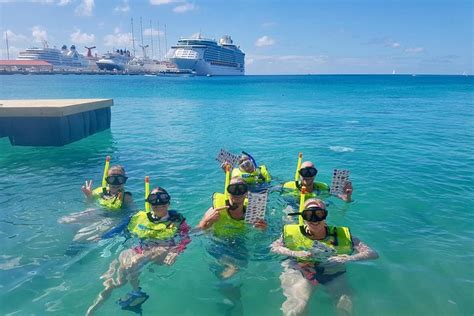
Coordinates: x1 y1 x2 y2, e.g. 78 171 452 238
212 193 248 238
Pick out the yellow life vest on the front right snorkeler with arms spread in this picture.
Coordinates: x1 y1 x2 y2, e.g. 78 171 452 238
283 224 353 261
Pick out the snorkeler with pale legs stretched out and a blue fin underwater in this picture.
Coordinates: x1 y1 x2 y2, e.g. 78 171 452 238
86 187 191 315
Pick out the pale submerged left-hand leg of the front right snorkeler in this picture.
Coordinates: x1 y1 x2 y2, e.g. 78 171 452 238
280 260 312 316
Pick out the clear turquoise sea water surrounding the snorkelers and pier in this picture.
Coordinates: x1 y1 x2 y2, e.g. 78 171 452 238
0 75 474 315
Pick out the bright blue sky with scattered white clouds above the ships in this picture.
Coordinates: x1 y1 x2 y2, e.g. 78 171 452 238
0 0 474 74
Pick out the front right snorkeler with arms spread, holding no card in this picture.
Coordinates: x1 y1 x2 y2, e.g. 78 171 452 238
271 199 378 315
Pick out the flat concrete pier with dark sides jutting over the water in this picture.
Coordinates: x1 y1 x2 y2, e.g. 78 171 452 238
0 99 113 146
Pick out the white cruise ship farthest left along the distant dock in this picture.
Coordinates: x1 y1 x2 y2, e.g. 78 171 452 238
17 42 89 68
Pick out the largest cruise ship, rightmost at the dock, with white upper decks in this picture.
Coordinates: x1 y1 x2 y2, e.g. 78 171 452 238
166 34 245 76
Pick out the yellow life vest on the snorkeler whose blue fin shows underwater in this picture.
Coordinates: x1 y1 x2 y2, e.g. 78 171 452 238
127 211 184 240
